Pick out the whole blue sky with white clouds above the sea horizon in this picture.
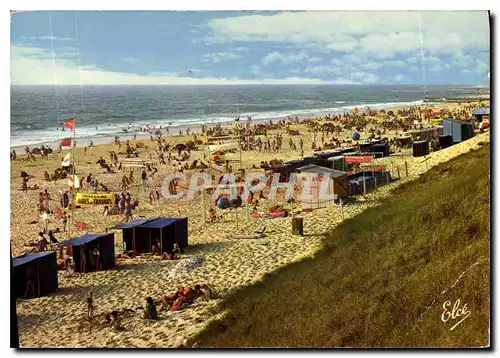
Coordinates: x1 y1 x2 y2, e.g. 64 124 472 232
11 11 490 85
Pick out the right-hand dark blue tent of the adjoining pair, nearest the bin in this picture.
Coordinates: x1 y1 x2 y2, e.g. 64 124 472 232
136 217 188 253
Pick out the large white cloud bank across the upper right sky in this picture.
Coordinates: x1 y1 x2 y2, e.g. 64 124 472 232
208 11 490 58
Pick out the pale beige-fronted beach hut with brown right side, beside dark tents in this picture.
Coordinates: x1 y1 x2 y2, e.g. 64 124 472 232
297 164 348 209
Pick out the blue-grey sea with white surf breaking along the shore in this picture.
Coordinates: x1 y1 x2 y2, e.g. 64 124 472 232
10 85 486 147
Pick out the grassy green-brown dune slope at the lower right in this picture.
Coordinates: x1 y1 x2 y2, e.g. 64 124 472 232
189 144 490 348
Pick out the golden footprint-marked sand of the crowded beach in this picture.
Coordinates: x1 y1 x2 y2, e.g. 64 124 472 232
11 103 490 348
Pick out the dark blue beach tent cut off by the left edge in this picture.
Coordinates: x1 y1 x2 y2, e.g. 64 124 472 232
12 251 58 297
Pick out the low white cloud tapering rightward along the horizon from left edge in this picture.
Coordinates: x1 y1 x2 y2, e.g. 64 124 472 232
11 46 359 85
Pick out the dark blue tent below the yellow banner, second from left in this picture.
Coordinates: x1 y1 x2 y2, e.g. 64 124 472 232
59 233 115 273
